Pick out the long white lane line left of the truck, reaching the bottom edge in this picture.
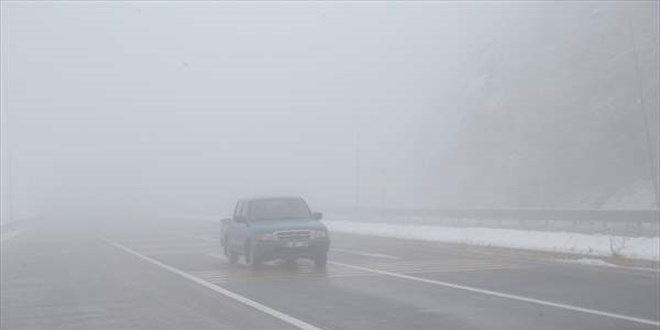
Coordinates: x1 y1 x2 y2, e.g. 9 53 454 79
104 239 323 330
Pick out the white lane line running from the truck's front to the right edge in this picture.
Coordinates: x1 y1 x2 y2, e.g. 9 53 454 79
328 261 660 327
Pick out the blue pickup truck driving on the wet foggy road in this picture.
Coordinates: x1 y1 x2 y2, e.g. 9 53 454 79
220 197 330 268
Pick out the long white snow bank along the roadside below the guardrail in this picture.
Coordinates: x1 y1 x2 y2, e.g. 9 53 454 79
325 220 660 261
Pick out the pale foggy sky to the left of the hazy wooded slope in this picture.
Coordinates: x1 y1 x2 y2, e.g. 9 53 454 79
1 1 657 219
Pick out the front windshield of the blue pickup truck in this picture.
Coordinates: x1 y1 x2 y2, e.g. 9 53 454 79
248 198 311 221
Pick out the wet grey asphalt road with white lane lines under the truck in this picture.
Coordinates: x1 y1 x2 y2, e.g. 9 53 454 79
0 221 660 330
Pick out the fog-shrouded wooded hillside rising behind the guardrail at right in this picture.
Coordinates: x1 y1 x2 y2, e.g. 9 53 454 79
419 2 660 208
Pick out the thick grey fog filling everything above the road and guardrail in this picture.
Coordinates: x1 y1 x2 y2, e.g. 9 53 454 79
1 2 660 219
